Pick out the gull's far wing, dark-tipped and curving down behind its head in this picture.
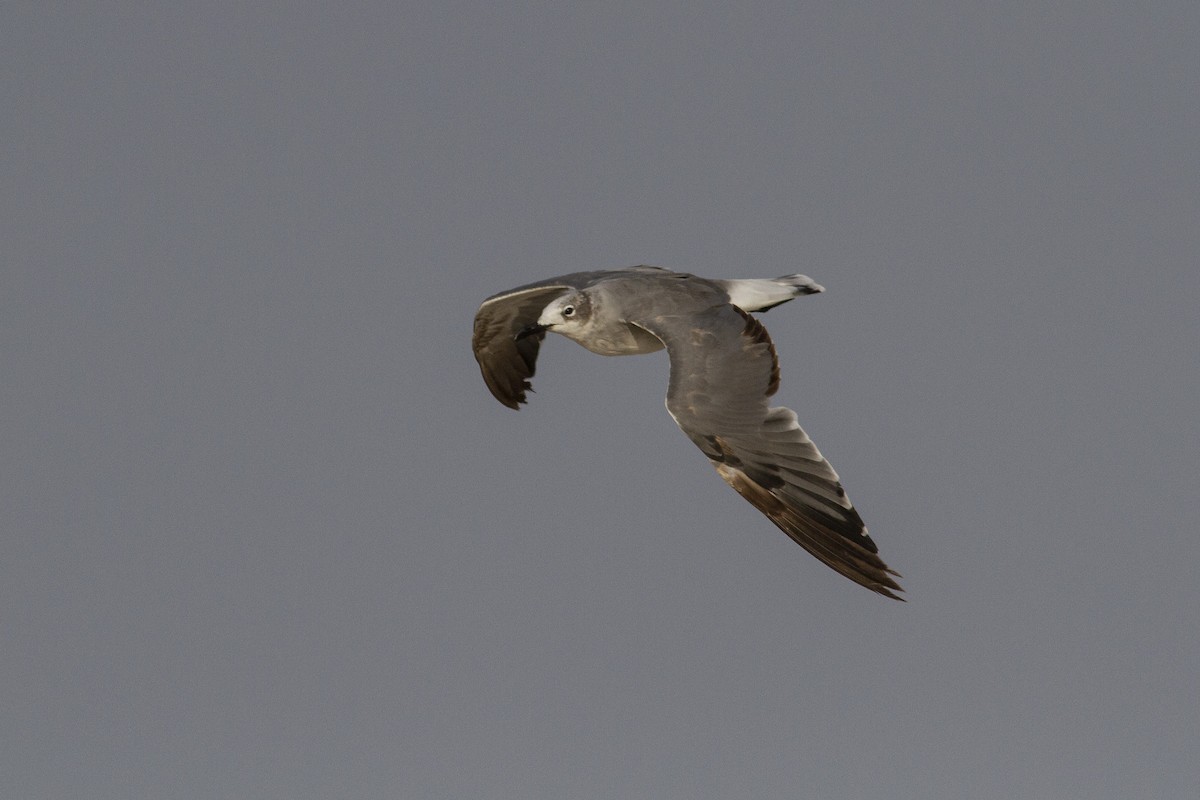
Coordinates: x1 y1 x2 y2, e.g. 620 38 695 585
470 266 666 409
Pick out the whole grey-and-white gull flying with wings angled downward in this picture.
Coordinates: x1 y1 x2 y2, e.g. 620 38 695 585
472 266 904 600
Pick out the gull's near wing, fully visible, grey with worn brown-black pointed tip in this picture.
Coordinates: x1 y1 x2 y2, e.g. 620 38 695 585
640 305 904 600
